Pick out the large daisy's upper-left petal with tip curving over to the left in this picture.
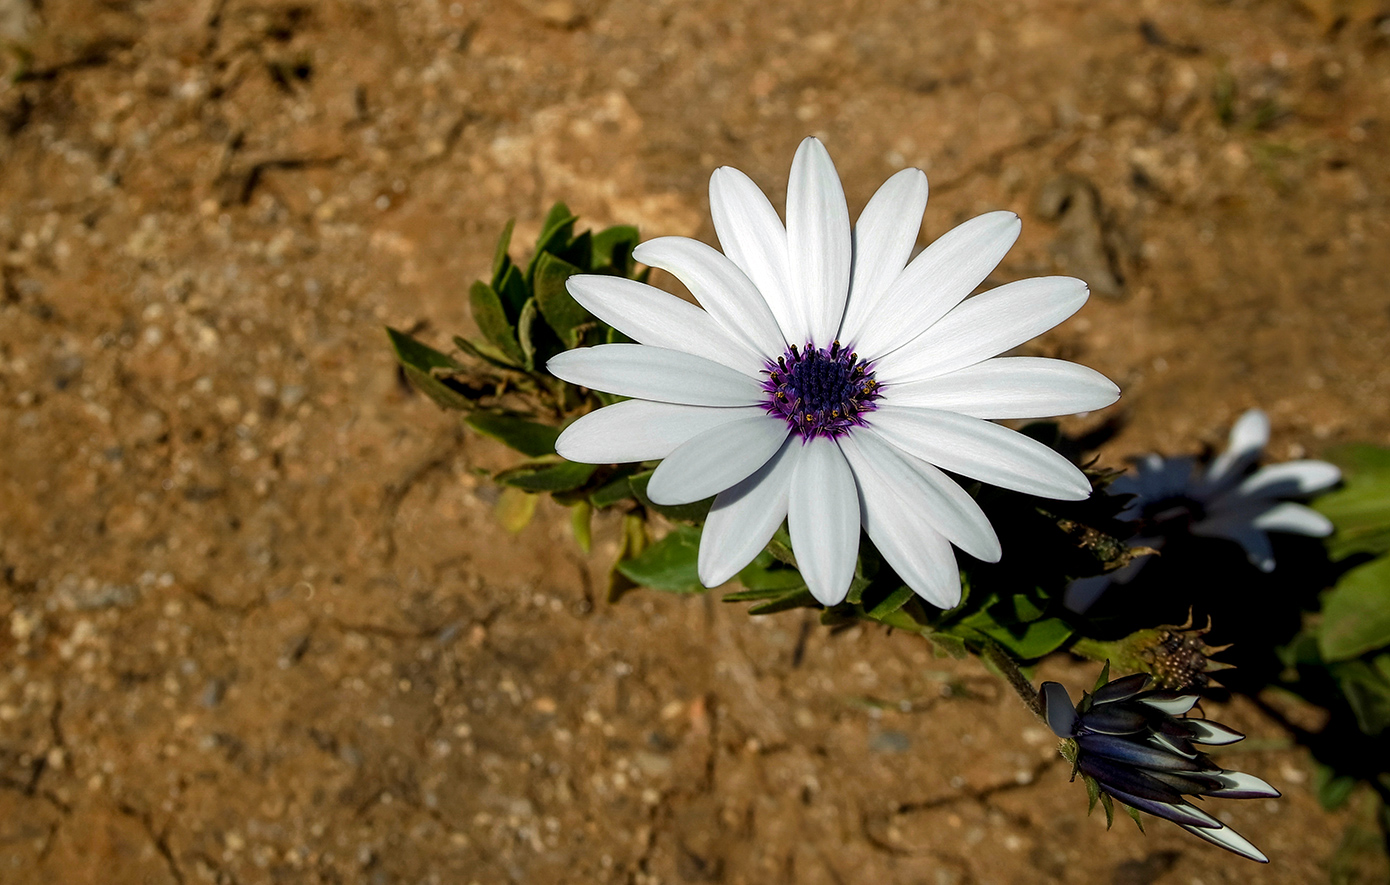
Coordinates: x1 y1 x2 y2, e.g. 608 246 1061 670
632 236 787 358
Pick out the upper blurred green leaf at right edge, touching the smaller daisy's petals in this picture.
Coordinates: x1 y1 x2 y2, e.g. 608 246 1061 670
1312 446 1390 560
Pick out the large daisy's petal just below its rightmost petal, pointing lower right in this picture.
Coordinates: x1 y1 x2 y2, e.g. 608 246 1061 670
867 406 1091 500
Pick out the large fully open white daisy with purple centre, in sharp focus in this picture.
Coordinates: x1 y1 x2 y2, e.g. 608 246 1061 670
548 139 1119 609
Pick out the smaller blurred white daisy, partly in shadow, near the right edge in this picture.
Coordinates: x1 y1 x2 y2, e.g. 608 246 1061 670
1065 408 1341 611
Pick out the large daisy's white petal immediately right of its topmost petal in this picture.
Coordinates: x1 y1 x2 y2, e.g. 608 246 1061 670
840 169 927 340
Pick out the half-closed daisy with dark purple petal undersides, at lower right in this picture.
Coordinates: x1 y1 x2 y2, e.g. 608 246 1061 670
1043 674 1279 863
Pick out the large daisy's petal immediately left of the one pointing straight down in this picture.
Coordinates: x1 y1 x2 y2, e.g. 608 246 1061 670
699 435 802 586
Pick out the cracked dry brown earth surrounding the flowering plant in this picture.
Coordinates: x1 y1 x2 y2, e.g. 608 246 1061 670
0 0 1390 885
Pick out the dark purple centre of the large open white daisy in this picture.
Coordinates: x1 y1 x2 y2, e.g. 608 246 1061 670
763 342 883 440
